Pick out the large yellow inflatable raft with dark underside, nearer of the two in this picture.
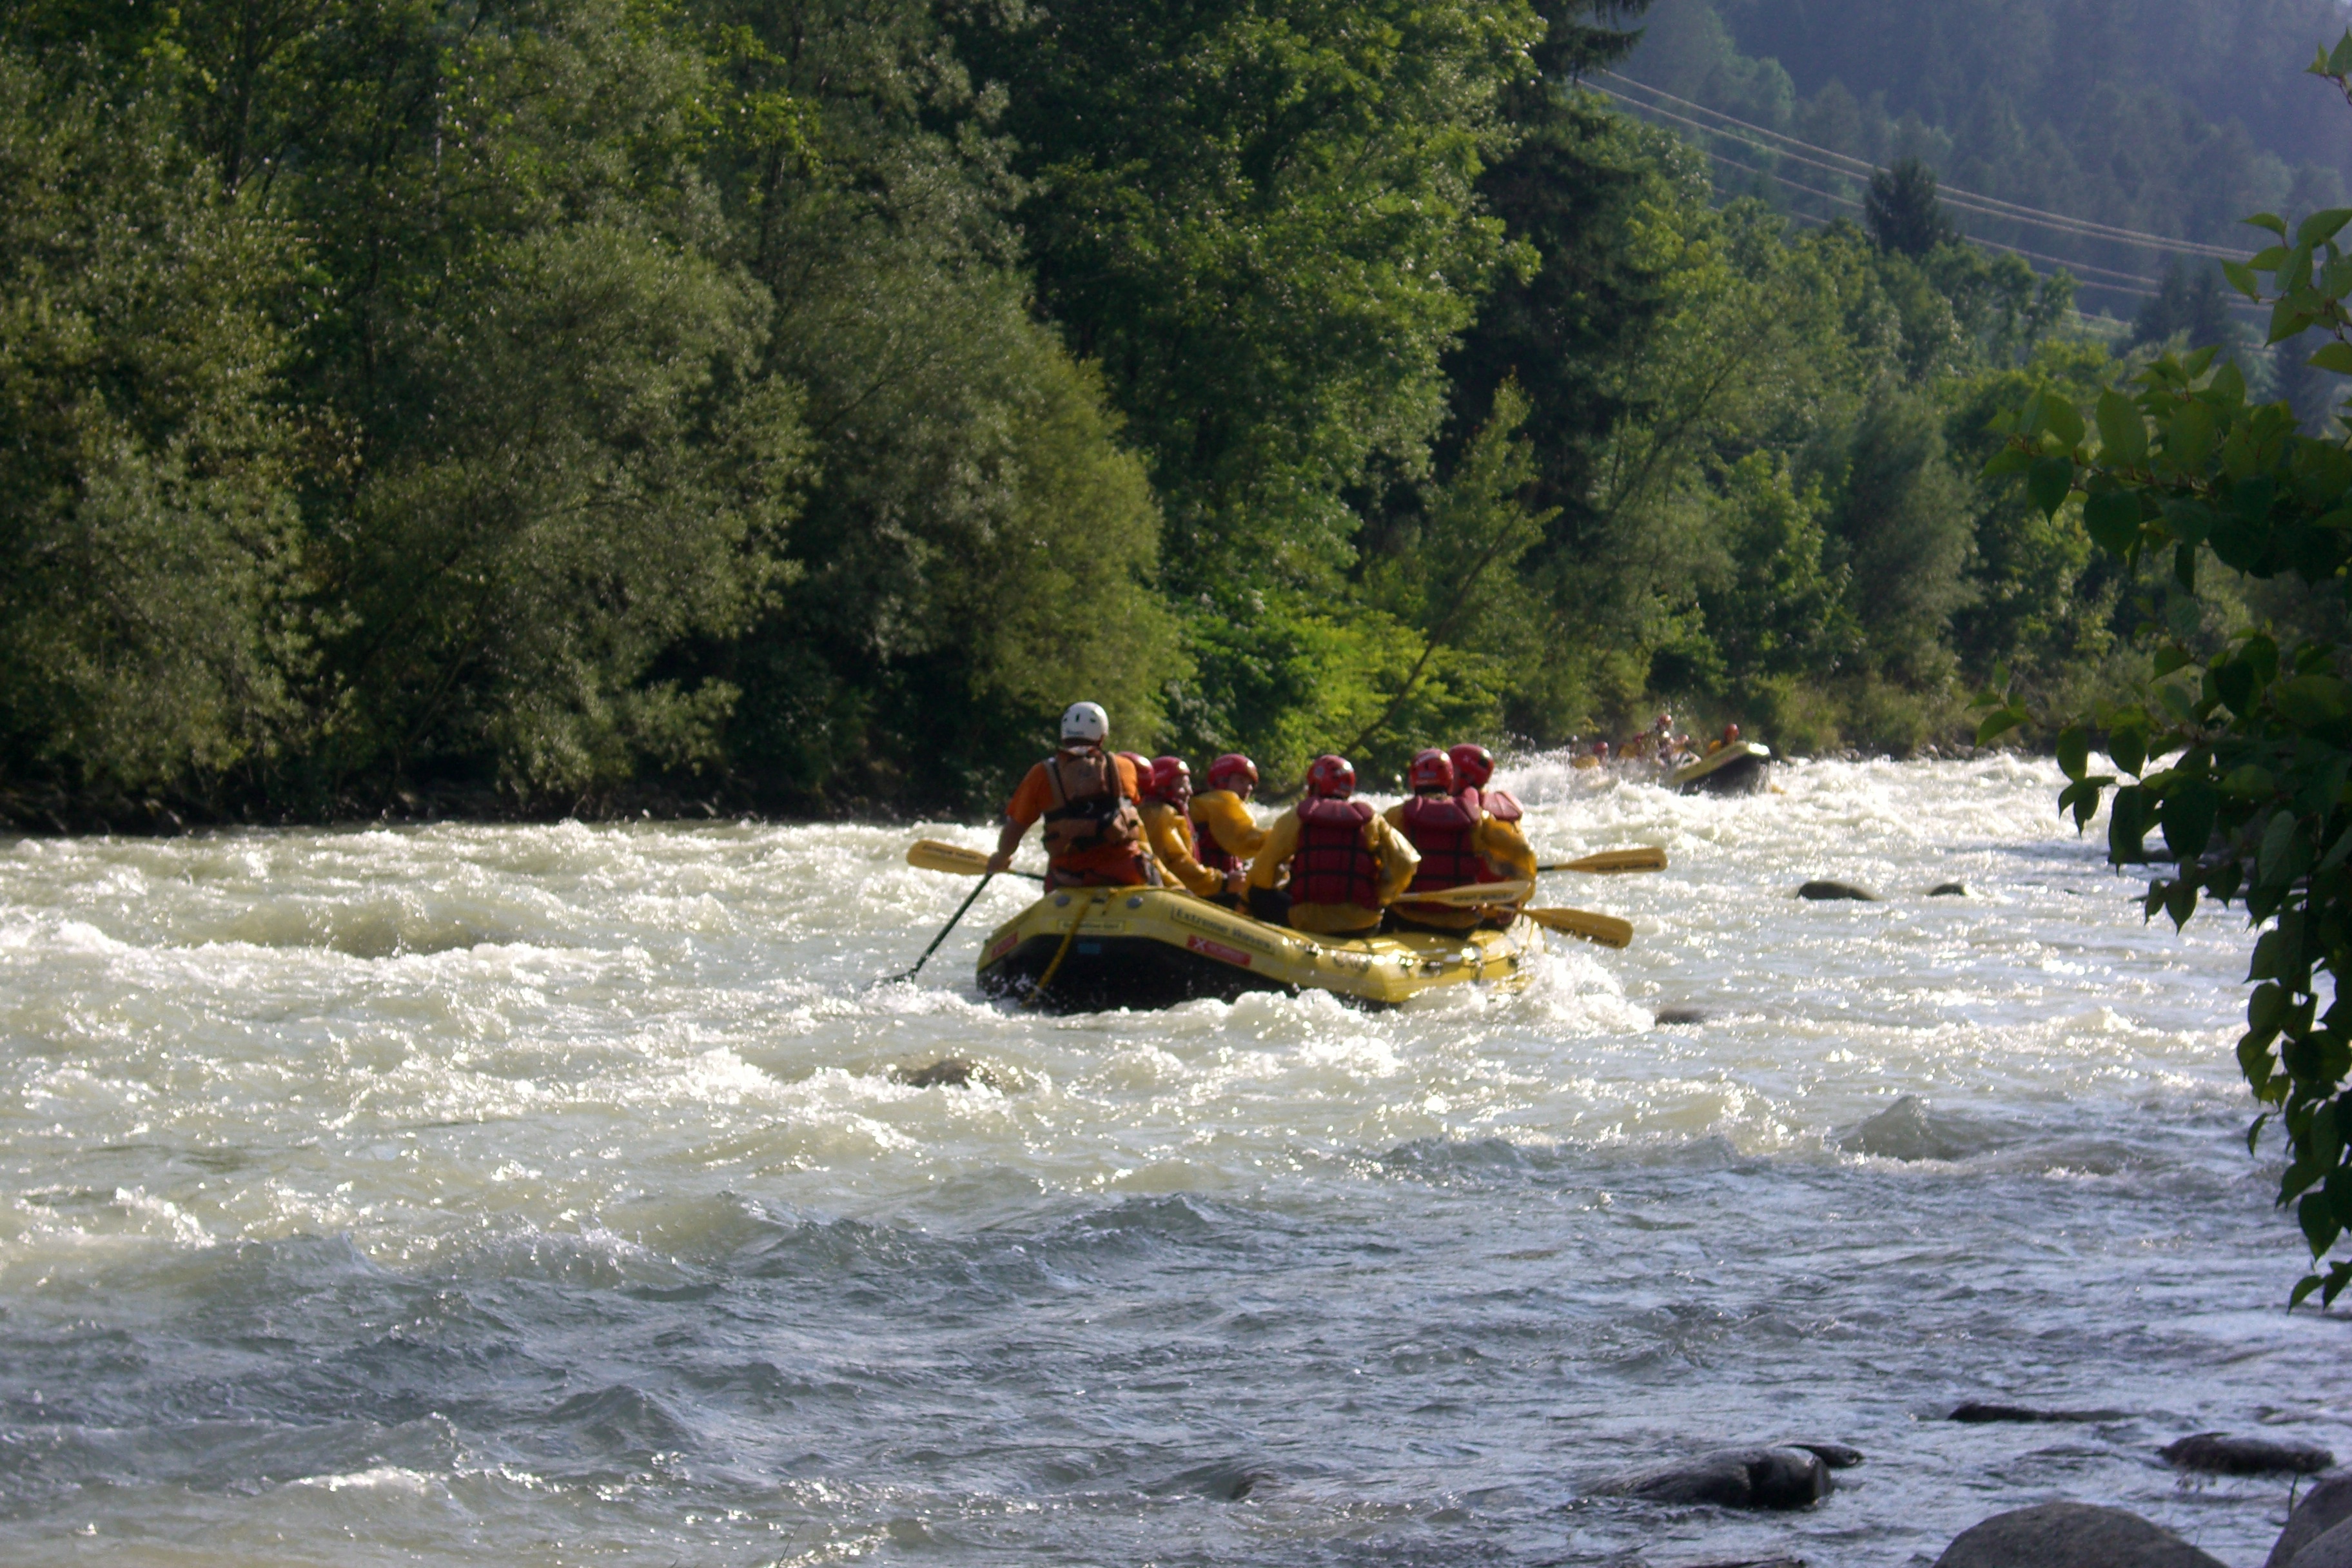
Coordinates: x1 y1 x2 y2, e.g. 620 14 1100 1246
981 887 1543 1011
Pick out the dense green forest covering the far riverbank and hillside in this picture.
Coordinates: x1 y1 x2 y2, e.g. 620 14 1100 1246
0 0 2345 825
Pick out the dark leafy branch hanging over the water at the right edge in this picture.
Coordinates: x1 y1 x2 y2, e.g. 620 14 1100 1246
1978 126 2352 1305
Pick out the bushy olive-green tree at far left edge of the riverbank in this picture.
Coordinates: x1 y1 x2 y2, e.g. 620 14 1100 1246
0 54 308 799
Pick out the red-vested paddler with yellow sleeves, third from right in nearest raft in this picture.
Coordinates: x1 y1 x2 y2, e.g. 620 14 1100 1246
1249 754 1420 936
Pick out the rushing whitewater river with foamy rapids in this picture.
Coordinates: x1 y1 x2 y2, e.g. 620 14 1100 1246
0 761 2352 1568
